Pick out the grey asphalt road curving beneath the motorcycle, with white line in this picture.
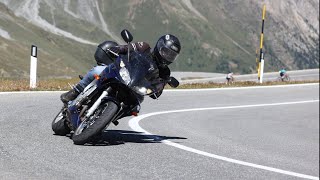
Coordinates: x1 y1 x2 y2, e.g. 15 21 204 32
0 84 319 179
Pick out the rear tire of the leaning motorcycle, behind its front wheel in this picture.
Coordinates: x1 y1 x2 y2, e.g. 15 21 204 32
51 108 70 136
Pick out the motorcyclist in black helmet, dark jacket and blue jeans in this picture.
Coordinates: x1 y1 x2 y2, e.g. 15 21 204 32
60 34 181 103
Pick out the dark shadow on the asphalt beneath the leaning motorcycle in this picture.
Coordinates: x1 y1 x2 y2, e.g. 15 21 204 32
86 130 187 146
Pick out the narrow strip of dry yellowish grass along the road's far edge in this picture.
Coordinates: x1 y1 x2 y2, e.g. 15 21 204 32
0 78 319 92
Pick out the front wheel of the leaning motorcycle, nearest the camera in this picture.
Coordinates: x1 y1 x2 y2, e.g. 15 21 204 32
72 101 118 145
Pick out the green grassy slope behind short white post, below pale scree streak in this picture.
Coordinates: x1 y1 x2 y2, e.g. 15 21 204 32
0 4 95 77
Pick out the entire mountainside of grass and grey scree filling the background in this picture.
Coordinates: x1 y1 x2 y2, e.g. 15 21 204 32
0 0 319 77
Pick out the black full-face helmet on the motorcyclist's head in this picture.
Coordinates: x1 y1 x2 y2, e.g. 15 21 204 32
153 34 181 65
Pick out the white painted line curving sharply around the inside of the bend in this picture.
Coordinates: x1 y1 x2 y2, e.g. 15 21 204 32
129 100 319 180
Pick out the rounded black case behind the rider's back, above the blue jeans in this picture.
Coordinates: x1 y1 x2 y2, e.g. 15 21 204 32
94 41 118 65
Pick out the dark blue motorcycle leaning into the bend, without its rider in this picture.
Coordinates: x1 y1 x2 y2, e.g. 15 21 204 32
52 30 179 145
